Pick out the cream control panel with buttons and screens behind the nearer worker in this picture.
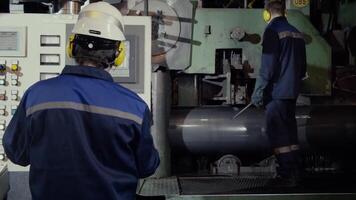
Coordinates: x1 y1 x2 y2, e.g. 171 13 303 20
0 14 151 171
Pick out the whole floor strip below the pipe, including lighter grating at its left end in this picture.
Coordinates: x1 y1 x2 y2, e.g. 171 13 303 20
138 175 356 196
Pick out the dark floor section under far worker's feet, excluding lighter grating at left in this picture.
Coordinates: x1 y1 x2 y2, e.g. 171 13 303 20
178 174 356 195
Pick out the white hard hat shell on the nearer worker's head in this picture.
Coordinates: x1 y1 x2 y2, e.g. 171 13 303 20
72 1 125 41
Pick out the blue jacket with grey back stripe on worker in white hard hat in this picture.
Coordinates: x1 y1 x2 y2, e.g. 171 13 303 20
5 66 159 200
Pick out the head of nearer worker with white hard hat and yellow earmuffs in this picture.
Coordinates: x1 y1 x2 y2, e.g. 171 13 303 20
67 2 125 68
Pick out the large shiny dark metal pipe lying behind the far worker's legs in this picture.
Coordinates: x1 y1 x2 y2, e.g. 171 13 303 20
169 106 356 156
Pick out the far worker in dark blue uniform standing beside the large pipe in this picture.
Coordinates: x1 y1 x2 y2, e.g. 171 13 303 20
252 1 306 186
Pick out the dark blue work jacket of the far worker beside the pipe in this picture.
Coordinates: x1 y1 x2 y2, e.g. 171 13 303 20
256 17 307 99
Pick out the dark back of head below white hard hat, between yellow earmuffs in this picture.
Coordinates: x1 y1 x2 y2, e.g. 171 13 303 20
73 34 118 69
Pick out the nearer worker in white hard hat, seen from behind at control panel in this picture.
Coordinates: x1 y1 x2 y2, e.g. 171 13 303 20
3 2 159 200
